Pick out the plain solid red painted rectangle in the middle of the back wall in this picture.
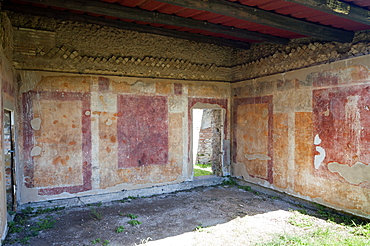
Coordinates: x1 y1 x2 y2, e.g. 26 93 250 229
117 95 168 168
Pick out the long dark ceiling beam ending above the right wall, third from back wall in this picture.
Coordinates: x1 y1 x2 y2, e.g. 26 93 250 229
156 0 354 43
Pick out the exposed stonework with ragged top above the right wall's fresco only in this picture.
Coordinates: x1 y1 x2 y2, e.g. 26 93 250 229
232 32 370 81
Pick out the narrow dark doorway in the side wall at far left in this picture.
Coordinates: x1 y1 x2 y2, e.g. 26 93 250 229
4 109 16 212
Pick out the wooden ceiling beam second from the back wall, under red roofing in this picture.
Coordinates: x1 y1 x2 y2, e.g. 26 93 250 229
13 0 289 44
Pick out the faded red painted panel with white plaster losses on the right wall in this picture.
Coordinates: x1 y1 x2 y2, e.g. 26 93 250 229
313 85 370 188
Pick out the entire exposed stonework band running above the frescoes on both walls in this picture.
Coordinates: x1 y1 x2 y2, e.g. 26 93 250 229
9 12 370 82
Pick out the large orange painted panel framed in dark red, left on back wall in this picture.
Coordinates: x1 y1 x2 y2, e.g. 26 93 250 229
23 91 91 195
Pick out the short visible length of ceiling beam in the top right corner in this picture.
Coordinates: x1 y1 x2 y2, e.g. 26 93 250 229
285 0 370 25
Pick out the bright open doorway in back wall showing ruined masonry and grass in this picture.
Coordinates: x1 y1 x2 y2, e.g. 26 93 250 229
192 108 223 177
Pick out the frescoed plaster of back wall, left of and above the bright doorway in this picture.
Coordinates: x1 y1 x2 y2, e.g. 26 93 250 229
20 71 229 203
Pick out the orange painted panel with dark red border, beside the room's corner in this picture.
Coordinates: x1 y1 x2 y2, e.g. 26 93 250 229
233 96 273 183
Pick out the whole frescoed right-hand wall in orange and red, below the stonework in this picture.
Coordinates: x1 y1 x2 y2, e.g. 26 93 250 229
232 56 370 218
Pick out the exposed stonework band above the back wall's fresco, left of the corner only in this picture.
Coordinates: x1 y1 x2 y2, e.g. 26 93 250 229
10 13 233 81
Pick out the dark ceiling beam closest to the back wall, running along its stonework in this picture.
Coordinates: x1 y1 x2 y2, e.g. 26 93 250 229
2 3 250 49
